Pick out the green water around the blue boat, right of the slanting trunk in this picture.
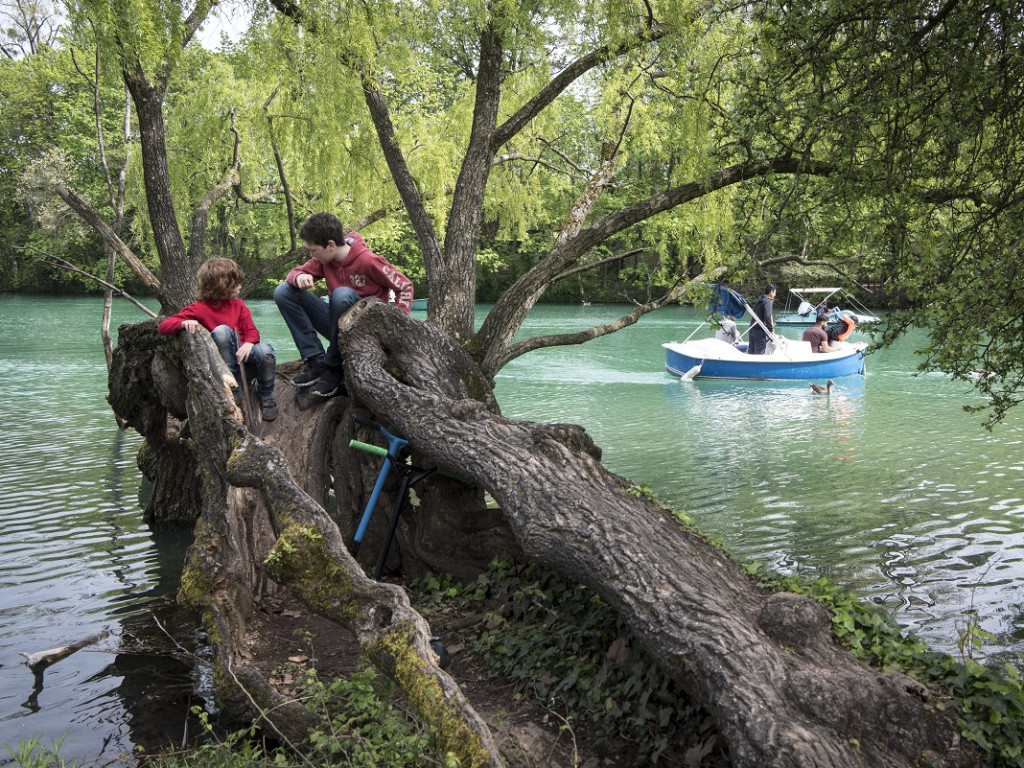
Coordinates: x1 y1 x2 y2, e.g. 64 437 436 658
498 306 1024 652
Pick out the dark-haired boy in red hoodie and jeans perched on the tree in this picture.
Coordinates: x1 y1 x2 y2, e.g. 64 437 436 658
273 212 413 397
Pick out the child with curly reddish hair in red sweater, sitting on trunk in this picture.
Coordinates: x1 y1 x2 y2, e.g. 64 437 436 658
157 258 278 421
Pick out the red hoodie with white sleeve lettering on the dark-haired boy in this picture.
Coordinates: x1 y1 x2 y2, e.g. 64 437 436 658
285 232 413 314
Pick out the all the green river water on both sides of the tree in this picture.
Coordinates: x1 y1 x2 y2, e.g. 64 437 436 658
0 295 1024 765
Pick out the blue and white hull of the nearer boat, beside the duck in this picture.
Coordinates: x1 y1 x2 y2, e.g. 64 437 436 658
662 339 866 381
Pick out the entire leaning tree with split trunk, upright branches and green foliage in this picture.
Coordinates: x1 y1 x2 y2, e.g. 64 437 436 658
29 0 1021 766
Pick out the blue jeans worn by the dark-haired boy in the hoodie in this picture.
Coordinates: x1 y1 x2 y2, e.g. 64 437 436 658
273 283 359 368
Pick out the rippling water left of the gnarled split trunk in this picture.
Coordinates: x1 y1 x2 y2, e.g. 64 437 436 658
0 296 195 765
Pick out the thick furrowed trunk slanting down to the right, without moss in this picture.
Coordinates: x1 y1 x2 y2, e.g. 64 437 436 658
331 304 977 768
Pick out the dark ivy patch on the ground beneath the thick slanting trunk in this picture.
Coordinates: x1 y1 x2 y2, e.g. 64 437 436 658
413 560 699 764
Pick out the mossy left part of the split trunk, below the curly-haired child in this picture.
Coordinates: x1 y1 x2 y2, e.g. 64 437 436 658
111 321 501 766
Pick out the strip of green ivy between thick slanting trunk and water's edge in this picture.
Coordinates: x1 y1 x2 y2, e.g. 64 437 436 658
744 564 1024 768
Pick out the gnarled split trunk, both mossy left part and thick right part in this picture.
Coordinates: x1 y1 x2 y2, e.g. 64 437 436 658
112 302 978 768
